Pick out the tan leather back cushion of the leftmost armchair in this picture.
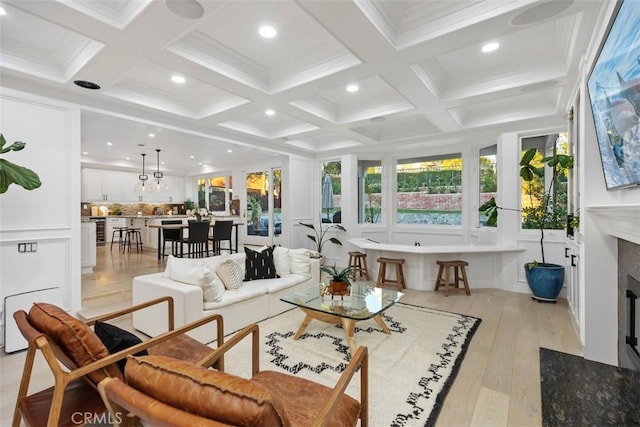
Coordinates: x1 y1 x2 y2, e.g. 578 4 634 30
29 303 122 384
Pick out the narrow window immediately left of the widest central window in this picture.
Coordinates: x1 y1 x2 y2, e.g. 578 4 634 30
358 160 382 224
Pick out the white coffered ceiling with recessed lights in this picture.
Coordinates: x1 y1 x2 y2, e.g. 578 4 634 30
0 0 611 174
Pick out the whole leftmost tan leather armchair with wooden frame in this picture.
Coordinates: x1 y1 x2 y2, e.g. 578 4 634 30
12 297 224 427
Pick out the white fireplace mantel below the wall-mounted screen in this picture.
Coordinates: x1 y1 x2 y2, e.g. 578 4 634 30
586 204 640 245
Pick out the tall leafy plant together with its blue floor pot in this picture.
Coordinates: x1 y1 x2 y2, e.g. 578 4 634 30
479 148 573 301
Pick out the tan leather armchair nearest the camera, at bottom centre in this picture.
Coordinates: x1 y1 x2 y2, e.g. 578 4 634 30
98 324 368 427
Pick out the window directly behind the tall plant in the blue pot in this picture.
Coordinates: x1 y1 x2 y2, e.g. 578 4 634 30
520 132 569 230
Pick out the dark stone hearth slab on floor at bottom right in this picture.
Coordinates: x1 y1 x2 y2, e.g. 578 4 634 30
540 348 640 426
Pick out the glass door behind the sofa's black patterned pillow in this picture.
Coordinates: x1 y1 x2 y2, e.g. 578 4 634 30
246 168 282 245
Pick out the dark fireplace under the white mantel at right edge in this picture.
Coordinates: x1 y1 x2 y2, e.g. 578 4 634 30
618 239 640 371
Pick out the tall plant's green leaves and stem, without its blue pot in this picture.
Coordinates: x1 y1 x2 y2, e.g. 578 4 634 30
479 148 573 264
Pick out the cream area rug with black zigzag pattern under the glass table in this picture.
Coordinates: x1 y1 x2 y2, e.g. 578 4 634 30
225 304 481 427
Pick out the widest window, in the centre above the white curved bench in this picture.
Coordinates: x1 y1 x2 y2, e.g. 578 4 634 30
396 153 462 225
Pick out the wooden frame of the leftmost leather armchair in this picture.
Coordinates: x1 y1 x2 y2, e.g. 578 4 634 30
12 296 224 427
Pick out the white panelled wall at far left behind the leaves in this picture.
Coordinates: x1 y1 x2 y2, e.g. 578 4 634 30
0 88 81 348
